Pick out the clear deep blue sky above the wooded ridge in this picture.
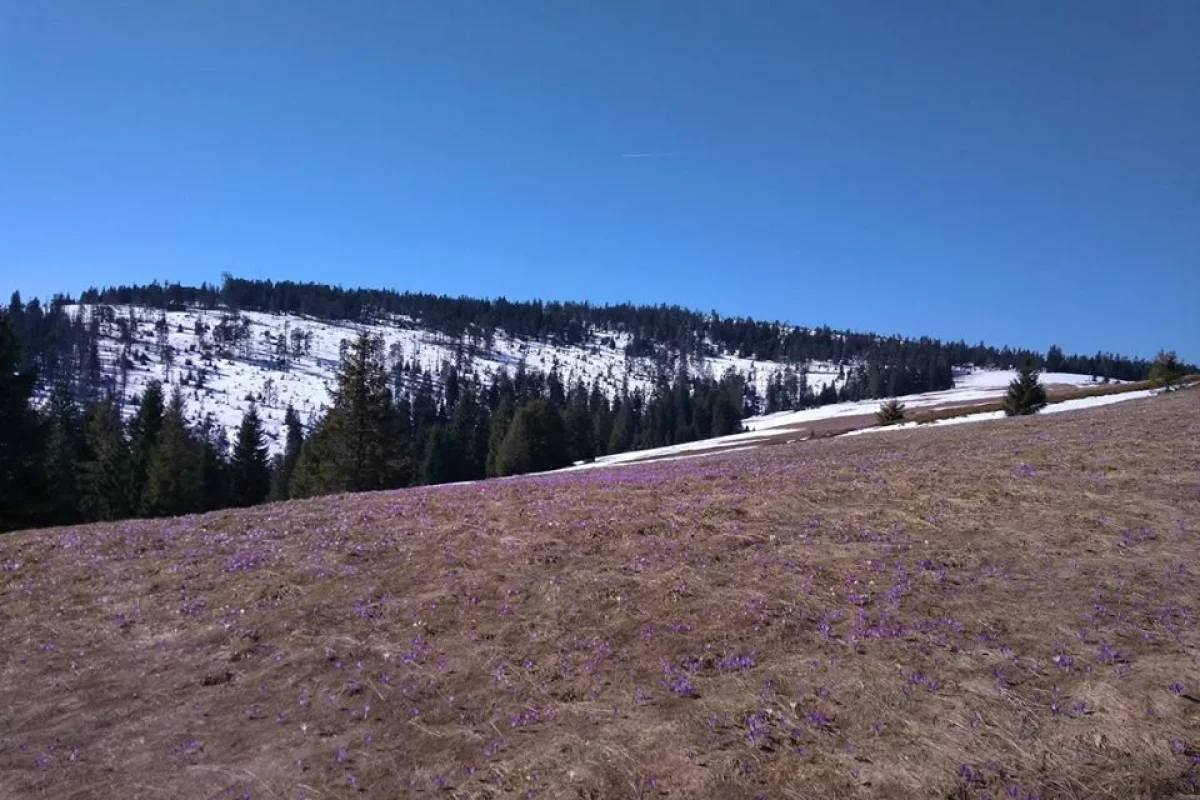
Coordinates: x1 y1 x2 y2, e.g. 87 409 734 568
0 0 1200 361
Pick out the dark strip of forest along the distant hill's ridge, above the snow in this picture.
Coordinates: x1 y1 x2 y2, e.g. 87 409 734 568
72 273 1150 383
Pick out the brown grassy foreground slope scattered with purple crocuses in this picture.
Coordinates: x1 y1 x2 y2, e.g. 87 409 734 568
0 391 1200 799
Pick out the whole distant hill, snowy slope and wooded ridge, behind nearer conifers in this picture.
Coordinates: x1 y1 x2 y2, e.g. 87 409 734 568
7 275 1150 455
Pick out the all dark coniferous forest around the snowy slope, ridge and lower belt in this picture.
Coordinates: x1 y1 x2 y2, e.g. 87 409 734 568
0 276 1180 530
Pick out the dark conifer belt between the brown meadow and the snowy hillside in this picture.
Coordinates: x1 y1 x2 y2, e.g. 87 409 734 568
0 311 751 530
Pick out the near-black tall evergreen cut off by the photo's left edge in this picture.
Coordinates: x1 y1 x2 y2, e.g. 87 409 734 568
0 311 47 531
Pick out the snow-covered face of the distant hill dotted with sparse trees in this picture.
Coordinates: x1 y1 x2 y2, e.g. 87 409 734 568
66 306 844 452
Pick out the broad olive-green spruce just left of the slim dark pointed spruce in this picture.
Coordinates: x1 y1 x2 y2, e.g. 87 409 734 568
138 387 204 517
